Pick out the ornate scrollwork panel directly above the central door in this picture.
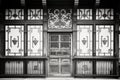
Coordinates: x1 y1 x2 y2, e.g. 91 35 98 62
48 9 72 29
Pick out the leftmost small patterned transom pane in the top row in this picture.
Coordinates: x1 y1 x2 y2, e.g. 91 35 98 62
5 9 24 20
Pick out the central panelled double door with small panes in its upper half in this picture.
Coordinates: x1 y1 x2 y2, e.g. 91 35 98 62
48 33 72 76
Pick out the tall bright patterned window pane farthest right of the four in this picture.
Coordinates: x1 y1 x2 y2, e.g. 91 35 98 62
96 25 114 56
